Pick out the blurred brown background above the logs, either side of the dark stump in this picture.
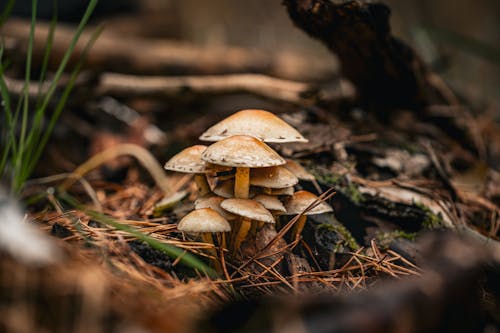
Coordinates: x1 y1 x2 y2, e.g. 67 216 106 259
5 0 500 104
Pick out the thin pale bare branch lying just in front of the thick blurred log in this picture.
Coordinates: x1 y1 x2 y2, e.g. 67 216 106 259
4 73 324 105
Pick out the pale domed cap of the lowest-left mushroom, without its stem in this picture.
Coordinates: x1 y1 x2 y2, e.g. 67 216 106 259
177 208 231 233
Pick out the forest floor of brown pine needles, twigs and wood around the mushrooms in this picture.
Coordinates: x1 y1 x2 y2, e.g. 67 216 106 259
0 0 500 332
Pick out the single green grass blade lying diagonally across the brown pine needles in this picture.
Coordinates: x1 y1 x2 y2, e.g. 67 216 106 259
60 193 216 277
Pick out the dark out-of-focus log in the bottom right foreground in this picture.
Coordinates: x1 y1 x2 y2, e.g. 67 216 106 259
203 233 500 333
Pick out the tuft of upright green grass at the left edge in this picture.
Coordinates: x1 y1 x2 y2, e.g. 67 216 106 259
0 0 101 194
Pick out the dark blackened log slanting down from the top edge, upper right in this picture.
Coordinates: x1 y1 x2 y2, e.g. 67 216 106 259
283 0 440 110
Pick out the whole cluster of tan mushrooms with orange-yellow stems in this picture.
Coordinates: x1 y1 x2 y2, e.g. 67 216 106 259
165 110 332 264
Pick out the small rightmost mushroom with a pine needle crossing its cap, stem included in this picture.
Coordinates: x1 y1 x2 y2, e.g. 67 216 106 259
285 191 333 239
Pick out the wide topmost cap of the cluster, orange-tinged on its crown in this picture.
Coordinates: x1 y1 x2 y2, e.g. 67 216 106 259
200 110 308 143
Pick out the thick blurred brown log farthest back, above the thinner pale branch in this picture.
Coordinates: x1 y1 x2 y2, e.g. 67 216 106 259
1 19 337 79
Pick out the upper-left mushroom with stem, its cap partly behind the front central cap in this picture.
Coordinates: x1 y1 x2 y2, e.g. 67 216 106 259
165 145 229 196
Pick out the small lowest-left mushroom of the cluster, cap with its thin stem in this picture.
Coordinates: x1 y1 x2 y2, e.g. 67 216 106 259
177 208 231 272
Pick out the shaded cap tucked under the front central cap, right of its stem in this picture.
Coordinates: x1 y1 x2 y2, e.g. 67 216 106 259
250 166 299 188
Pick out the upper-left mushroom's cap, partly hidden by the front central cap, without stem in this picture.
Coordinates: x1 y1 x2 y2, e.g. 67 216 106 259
165 145 229 173
